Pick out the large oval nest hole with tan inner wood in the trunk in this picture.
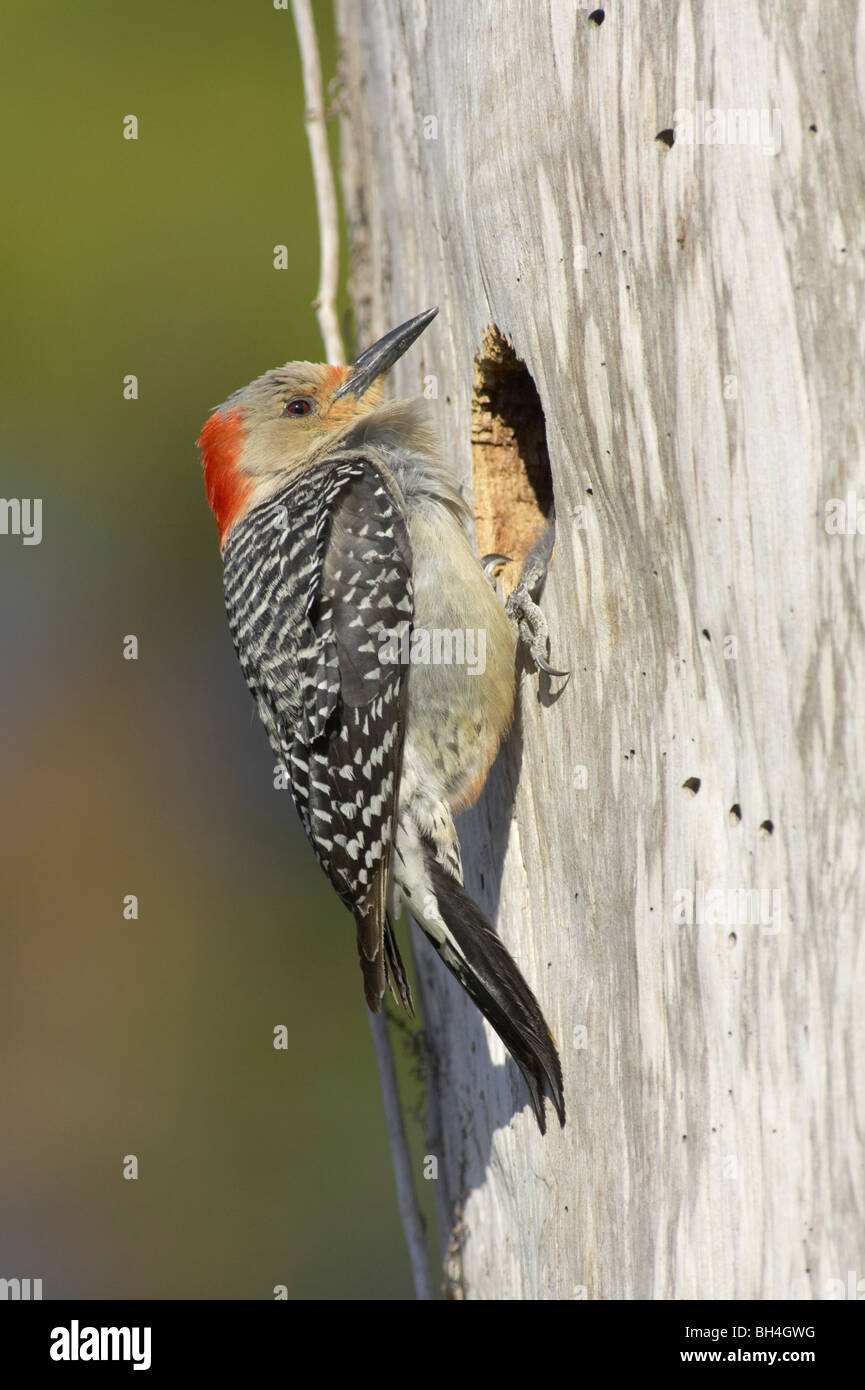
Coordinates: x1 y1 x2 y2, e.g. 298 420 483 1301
471 327 553 591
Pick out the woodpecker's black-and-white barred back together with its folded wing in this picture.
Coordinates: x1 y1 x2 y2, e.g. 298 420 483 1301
224 456 412 1009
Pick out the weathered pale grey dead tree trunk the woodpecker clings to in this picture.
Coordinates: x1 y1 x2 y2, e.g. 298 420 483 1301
338 0 865 1298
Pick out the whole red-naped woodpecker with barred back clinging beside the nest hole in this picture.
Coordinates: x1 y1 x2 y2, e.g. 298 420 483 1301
197 309 565 1133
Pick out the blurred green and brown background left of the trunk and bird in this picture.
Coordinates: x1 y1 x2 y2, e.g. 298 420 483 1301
0 0 428 1298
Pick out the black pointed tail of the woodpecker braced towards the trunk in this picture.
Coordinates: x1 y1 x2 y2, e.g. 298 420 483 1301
419 849 565 1134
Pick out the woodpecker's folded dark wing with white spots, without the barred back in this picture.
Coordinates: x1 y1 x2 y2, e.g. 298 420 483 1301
291 456 412 1011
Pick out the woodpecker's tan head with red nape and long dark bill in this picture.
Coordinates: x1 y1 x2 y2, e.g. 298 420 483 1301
197 309 438 545
